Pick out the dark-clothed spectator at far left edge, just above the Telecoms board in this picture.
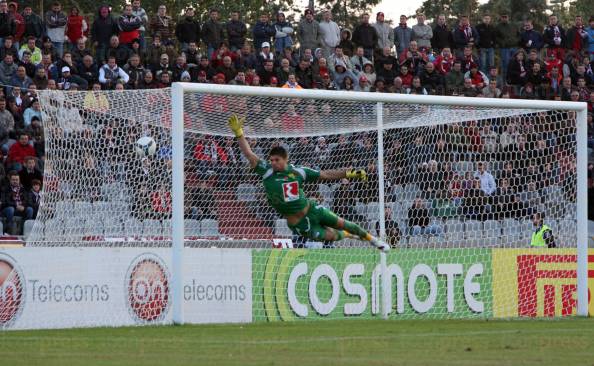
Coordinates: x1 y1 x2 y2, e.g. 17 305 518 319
2 171 33 235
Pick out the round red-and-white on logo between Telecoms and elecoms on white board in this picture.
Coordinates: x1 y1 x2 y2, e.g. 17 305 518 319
124 253 170 323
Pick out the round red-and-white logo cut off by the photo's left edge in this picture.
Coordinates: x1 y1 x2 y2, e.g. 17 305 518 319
0 253 26 328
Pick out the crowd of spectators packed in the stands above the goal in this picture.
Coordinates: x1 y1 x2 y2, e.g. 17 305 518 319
0 0 594 237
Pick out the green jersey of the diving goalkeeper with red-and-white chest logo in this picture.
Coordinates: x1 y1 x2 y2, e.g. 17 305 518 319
254 160 320 216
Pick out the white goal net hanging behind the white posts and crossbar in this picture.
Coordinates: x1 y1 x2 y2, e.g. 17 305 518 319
8 85 585 323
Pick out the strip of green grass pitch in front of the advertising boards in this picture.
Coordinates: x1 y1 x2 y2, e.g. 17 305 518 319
0 318 594 366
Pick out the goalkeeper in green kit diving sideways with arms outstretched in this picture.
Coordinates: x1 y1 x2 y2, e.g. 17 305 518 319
229 114 390 251
